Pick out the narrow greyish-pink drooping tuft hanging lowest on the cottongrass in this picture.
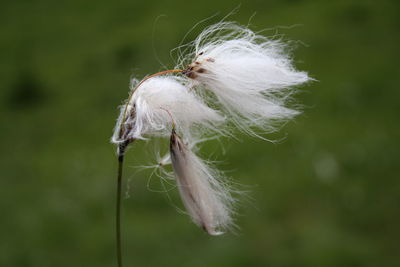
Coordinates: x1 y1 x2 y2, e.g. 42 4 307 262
170 131 234 235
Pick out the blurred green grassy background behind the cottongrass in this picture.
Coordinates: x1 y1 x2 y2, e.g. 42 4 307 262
0 0 400 267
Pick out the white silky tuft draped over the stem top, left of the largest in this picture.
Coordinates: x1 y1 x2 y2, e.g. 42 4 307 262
112 76 224 144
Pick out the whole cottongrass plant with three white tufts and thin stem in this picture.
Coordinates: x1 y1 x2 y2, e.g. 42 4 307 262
111 22 311 267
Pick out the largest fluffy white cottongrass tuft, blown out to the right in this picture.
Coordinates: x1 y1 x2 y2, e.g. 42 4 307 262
180 22 311 135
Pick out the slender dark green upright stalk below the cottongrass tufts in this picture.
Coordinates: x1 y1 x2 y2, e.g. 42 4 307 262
115 154 124 267
